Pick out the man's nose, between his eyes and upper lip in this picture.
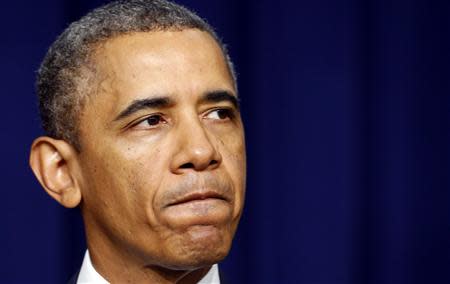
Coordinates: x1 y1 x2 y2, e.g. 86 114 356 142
171 119 222 174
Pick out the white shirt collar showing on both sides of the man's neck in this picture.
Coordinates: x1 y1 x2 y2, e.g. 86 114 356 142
77 251 220 284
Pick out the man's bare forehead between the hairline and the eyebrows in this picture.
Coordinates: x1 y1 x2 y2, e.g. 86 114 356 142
89 29 234 104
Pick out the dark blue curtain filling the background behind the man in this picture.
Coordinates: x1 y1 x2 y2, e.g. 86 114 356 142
0 0 450 284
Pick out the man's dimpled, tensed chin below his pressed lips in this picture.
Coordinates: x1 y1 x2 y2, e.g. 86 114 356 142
163 225 232 270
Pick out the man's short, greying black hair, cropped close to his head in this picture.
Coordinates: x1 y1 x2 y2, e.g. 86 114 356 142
36 0 236 150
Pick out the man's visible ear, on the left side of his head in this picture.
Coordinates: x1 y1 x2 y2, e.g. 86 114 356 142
30 137 81 208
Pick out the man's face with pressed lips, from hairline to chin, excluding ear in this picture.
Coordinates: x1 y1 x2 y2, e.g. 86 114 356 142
78 29 246 269
